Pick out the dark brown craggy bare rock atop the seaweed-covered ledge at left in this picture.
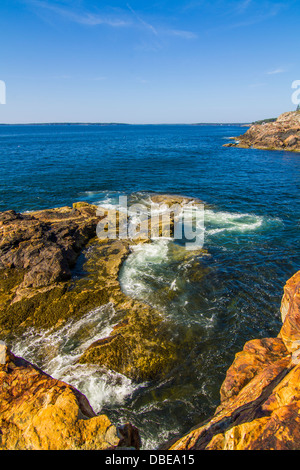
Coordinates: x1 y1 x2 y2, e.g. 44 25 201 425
0 204 97 288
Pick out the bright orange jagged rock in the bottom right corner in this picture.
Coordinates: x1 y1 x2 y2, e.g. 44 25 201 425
169 271 300 450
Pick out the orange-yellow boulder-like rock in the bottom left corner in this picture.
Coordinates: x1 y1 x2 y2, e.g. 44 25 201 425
0 345 140 450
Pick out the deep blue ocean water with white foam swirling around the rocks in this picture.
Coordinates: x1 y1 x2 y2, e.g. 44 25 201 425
0 125 300 449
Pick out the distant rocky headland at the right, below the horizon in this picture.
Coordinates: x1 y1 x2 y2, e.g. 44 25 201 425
224 111 300 152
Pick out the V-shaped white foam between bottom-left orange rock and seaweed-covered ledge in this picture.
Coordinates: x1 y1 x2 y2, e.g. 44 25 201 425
13 304 136 412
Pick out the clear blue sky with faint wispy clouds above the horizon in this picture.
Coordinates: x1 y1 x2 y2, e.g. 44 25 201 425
0 0 300 124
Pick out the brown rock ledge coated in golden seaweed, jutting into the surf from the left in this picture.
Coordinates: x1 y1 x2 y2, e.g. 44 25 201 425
0 195 207 381
